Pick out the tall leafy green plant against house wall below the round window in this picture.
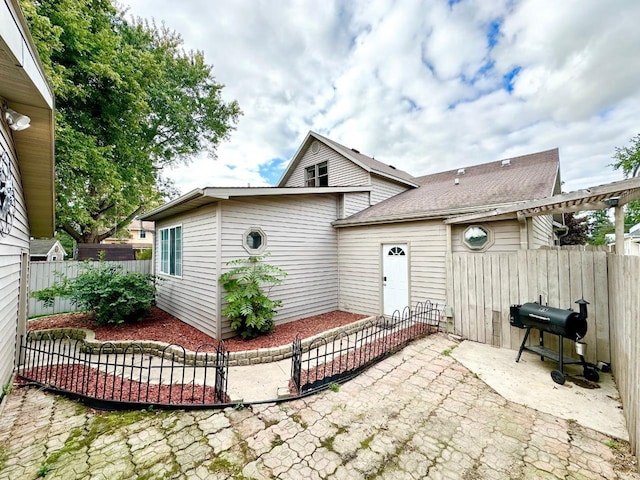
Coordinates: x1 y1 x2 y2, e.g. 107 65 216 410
219 253 287 339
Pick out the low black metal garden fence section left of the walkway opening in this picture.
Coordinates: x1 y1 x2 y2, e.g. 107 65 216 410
18 332 229 409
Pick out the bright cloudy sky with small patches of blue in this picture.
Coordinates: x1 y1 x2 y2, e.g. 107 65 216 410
121 0 640 193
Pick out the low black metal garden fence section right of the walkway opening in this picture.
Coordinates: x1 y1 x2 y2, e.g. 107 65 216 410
290 300 442 395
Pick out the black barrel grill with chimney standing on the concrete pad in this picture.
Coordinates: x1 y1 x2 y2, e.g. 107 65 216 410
509 299 600 385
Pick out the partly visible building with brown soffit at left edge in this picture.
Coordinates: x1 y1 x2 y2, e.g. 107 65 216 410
0 0 55 385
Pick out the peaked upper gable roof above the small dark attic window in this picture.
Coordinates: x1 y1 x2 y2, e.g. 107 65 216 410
278 131 418 187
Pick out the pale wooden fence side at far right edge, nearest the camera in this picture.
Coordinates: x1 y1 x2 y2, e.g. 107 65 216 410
598 255 640 458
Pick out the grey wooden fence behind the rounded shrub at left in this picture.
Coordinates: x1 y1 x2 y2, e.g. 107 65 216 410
29 260 151 317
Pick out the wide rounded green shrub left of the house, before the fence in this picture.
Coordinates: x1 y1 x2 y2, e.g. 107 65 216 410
31 262 156 324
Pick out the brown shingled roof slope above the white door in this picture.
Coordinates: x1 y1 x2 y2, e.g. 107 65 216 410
334 149 560 227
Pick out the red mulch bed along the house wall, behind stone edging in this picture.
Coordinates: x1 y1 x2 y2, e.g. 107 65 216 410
27 307 366 352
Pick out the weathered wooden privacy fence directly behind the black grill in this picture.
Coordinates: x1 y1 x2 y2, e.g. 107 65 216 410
449 249 611 363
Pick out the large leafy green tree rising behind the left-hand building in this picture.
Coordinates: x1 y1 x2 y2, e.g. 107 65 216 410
21 0 240 243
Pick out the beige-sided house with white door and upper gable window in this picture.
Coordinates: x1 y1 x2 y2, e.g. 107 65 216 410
141 127 560 338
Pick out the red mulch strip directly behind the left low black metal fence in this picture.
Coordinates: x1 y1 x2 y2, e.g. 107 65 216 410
21 365 229 405
